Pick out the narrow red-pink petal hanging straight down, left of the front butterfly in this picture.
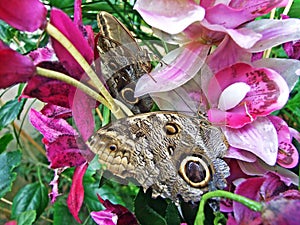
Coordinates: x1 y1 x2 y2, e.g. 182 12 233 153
67 163 88 223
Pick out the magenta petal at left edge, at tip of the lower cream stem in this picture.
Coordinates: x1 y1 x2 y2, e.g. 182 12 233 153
0 48 35 88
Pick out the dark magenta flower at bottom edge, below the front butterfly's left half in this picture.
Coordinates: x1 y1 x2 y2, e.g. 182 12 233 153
91 195 138 225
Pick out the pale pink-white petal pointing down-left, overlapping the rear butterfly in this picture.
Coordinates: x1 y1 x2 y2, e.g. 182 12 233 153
135 42 209 97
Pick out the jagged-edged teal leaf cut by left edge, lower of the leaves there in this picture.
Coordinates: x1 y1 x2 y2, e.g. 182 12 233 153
0 151 22 198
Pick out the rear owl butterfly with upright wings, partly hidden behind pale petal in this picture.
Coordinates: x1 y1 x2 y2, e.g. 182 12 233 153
97 12 153 114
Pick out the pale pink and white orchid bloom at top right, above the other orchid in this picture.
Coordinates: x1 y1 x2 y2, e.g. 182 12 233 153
135 0 300 96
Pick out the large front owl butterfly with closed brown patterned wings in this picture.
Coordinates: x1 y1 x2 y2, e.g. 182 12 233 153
88 111 229 203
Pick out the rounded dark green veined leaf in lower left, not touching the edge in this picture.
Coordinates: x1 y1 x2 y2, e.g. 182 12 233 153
12 182 49 218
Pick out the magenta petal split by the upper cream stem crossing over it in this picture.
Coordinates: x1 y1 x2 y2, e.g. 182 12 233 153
50 9 94 79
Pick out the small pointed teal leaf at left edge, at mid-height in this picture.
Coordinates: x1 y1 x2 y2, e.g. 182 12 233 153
0 99 24 130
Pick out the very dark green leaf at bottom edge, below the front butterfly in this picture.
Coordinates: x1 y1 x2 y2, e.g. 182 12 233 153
134 189 167 225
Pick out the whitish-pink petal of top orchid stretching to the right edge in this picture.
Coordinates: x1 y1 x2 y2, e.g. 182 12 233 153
244 19 300 52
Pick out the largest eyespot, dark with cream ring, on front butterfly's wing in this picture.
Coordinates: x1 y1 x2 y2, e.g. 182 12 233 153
178 156 213 188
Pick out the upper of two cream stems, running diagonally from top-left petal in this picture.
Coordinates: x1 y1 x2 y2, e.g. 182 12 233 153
45 23 124 118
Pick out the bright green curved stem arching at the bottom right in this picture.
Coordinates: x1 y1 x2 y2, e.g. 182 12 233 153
195 190 263 225
